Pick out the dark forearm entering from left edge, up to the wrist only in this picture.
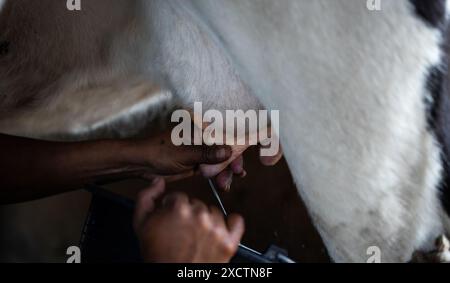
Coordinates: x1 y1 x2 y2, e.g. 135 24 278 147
0 135 143 203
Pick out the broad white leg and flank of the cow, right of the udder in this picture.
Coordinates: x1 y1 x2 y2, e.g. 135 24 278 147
178 0 443 261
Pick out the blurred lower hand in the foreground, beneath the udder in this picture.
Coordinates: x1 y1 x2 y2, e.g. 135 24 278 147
134 179 244 263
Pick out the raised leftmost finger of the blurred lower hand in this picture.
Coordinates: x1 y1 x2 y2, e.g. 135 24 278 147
133 178 165 230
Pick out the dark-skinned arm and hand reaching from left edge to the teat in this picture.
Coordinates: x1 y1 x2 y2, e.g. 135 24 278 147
0 134 231 204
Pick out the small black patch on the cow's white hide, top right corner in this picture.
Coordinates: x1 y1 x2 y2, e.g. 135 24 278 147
409 0 446 28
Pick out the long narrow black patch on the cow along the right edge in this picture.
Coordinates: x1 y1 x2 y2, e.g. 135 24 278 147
427 62 450 215
